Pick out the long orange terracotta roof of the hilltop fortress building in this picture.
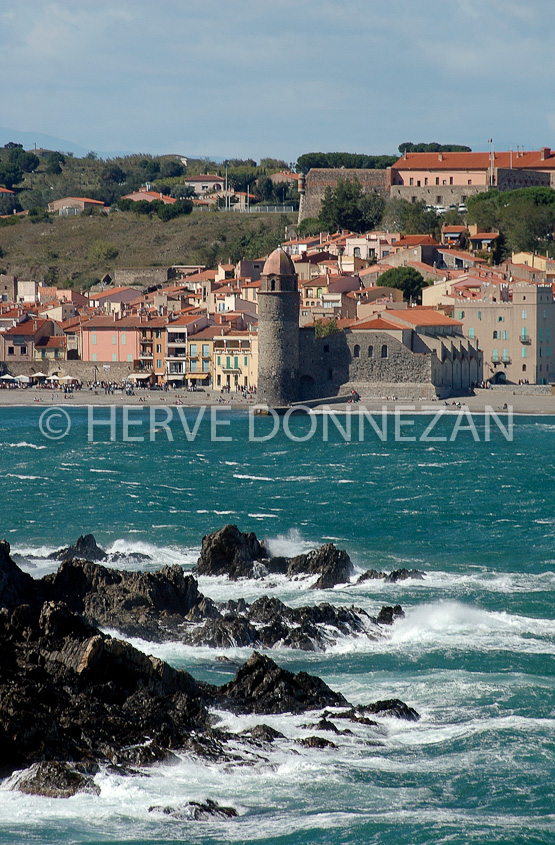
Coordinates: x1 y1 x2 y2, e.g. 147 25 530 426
392 148 555 171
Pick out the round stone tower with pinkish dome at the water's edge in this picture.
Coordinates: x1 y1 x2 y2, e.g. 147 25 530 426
258 249 300 407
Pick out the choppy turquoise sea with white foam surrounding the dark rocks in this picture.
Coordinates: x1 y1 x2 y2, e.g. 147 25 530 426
0 406 555 845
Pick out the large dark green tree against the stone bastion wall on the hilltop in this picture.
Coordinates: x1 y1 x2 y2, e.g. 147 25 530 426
320 179 385 232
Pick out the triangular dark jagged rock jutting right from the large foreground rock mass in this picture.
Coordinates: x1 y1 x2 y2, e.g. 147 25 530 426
215 651 346 713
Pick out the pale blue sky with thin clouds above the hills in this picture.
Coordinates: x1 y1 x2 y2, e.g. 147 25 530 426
0 0 555 162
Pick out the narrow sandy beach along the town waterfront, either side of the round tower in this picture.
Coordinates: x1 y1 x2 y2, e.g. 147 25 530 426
0 387 555 415
